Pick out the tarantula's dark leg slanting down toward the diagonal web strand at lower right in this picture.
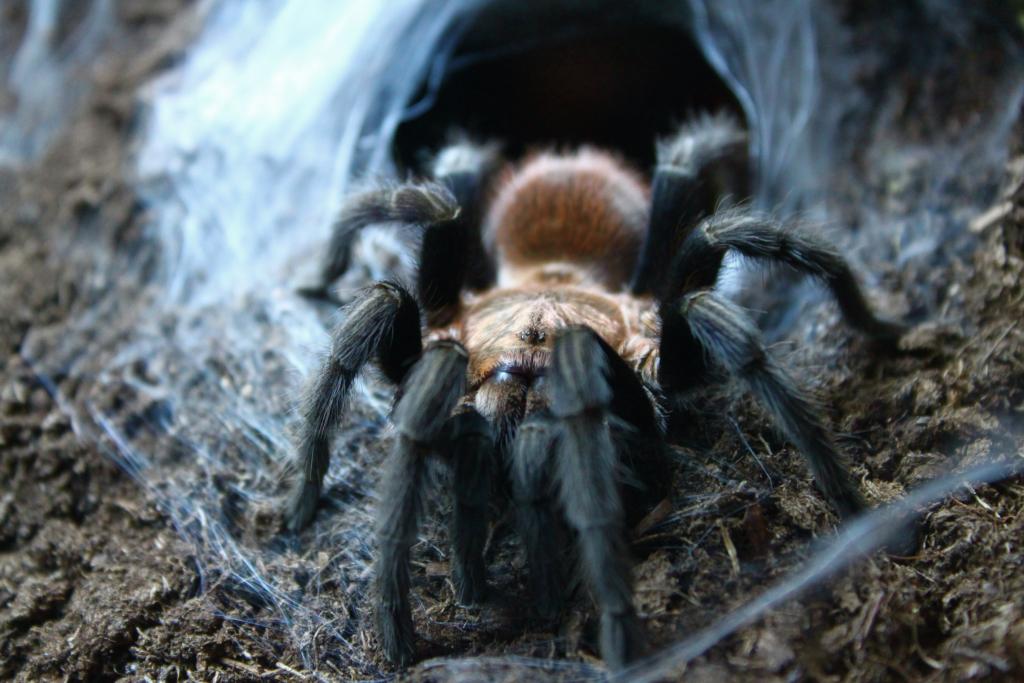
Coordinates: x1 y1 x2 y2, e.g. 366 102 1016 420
658 290 865 518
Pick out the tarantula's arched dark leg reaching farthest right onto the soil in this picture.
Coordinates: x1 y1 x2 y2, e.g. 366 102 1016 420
664 209 905 343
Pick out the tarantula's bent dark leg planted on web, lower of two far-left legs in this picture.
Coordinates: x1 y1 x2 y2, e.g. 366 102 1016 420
286 283 421 531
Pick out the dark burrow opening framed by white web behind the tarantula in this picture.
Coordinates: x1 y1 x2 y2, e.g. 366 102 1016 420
394 6 742 169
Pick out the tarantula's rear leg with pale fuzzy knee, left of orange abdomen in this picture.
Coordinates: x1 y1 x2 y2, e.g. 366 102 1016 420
421 138 501 290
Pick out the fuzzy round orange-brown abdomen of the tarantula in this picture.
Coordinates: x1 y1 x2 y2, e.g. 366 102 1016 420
484 148 647 291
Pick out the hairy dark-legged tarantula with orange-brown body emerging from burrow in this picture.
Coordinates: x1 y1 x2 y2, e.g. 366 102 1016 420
287 117 902 669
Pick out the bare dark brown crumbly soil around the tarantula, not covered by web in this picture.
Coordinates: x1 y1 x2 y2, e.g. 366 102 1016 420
0 0 1024 681
